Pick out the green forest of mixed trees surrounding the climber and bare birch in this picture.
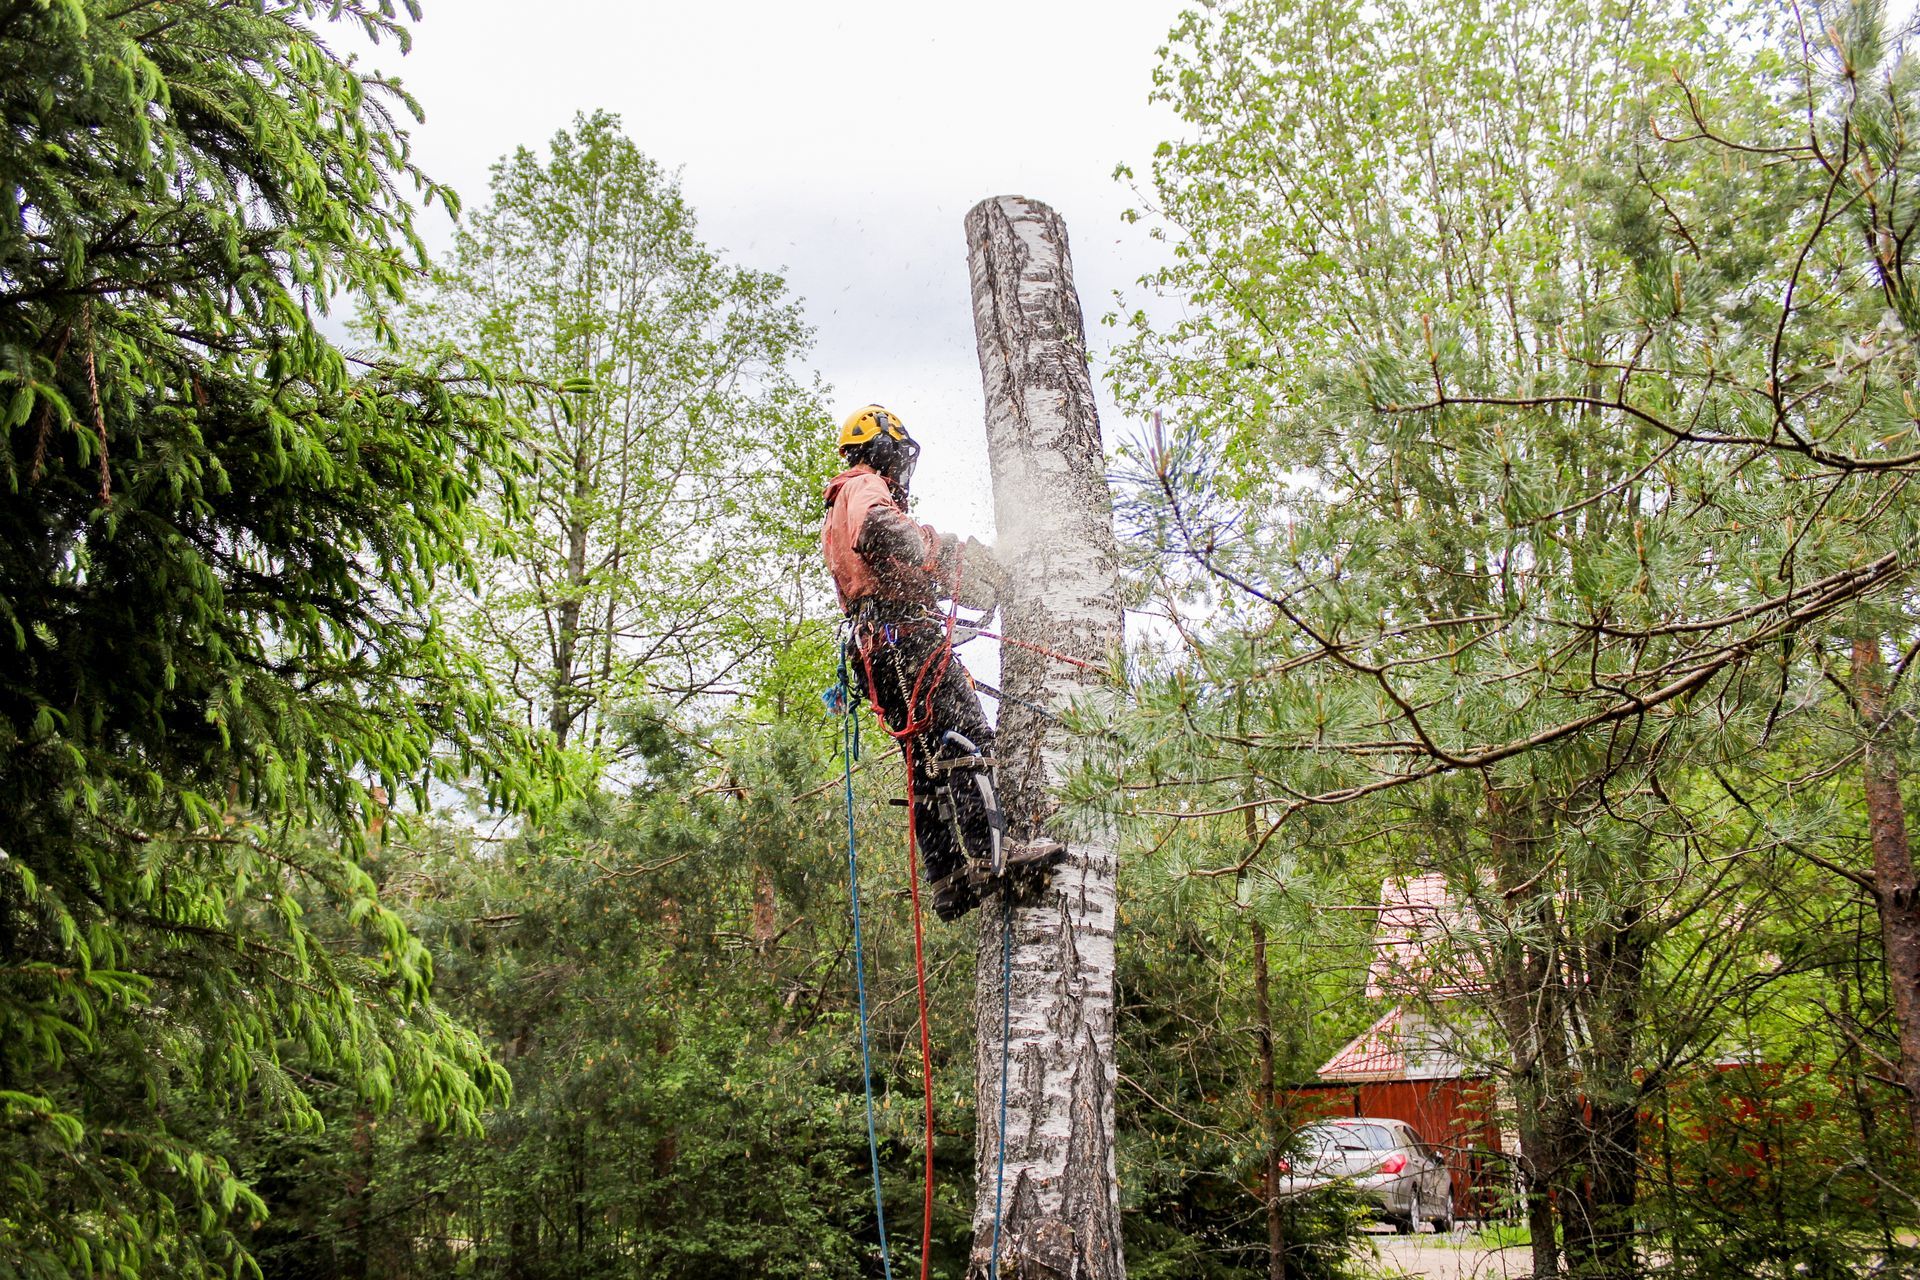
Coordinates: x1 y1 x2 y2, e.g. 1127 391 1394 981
0 0 1920 1280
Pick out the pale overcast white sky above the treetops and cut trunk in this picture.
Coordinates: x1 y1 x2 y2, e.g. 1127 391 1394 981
362 0 1185 533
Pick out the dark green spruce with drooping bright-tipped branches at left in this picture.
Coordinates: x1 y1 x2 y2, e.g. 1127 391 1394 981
0 0 534 1276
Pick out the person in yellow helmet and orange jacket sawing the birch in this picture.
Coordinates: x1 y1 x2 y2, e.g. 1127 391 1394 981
820 405 1066 919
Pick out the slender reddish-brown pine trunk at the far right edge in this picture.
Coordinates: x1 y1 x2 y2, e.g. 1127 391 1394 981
1853 637 1920 1150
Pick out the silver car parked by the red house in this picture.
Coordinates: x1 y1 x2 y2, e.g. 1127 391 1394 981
1281 1115 1453 1234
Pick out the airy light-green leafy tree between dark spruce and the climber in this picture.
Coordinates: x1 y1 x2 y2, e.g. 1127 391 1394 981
411 111 828 754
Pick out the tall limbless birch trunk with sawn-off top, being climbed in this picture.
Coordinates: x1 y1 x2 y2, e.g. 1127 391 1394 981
966 196 1125 1280
